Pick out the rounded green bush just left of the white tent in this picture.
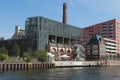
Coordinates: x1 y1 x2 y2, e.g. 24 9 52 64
37 50 48 62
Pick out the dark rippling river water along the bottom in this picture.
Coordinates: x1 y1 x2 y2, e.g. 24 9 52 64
0 67 120 80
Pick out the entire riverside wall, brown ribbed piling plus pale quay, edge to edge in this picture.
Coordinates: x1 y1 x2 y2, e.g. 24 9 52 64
0 60 120 71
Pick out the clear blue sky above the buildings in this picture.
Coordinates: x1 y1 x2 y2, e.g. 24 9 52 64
0 0 120 39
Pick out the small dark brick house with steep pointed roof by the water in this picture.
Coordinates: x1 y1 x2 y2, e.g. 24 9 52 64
86 35 106 60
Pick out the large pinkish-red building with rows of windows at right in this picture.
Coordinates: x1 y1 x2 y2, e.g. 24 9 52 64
83 19 120 53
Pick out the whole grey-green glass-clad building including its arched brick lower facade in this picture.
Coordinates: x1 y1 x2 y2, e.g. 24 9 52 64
25 16 82 60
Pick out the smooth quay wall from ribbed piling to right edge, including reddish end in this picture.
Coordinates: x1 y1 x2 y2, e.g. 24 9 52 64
53 60 120 68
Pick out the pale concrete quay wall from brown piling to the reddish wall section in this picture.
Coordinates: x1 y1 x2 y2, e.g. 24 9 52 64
53 61 106 67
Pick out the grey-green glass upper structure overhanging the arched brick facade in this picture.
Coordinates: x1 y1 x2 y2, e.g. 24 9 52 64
25 16 82 50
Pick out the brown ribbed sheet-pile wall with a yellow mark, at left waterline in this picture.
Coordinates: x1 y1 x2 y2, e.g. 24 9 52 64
0 63 55 70
